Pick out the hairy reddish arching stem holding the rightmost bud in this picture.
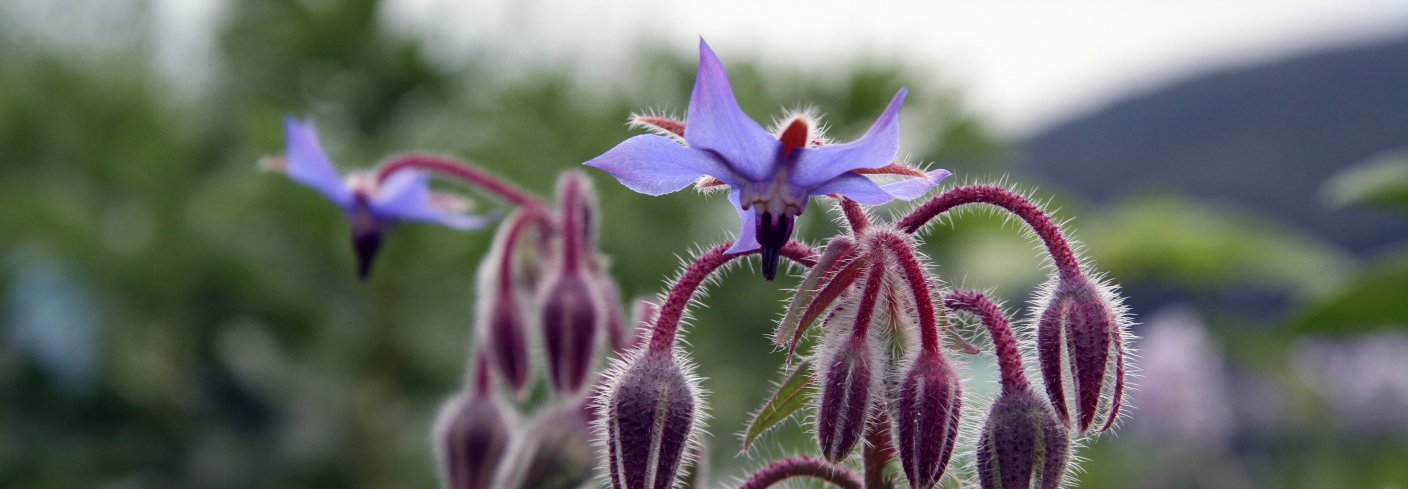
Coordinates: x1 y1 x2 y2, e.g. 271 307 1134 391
895 185 1081 280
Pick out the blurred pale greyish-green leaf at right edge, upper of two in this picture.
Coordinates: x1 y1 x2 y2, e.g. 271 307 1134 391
1325 152 1408 211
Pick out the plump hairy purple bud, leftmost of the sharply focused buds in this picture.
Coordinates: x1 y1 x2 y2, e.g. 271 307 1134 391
600 351 698 489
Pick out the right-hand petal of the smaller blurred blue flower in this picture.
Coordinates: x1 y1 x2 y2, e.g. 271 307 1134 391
372 171 489 231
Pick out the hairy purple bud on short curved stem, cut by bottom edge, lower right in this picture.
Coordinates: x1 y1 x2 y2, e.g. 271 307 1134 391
977 389 1070 489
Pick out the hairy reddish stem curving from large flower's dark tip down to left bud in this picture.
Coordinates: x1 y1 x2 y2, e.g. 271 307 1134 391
649 241 817 354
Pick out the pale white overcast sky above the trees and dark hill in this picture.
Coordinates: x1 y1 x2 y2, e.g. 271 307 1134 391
126 0 1408 137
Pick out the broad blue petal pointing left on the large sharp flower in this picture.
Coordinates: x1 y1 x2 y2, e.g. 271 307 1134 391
586 134 739 196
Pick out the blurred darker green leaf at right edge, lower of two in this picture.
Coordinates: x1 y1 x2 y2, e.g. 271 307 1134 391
1290 252 1408 334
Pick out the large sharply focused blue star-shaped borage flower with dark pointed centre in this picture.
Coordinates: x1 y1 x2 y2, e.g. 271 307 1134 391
586 39 949 280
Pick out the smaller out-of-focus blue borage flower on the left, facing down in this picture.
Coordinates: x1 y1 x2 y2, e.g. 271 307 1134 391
268 117 490 278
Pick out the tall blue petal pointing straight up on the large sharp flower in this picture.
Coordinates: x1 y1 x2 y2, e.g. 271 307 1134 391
684 39 781 182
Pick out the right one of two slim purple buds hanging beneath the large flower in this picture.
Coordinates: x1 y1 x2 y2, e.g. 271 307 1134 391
890 349 963 489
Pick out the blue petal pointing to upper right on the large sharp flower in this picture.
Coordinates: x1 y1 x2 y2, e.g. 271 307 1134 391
788 89 907 187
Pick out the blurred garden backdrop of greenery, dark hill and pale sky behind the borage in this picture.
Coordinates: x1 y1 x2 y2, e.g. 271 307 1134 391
0 0 1408 488
